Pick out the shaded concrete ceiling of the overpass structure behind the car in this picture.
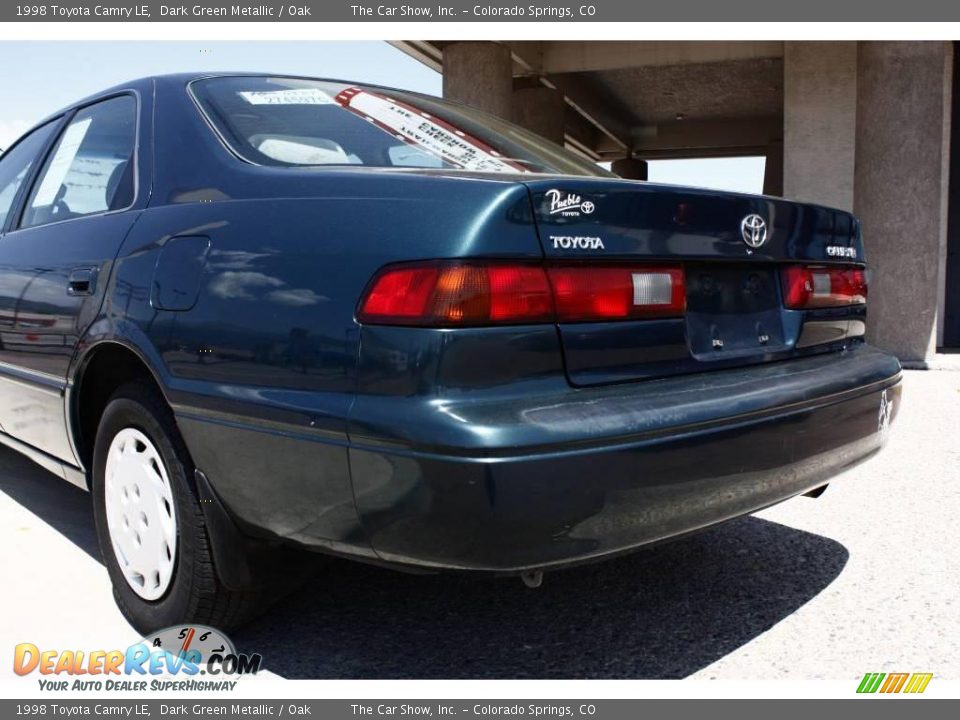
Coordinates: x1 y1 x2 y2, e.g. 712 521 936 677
394 41 783 160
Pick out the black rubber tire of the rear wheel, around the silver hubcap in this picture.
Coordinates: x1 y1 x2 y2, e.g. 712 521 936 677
92 382 274 633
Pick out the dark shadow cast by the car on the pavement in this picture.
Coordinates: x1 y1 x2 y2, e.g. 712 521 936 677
0 448 848 679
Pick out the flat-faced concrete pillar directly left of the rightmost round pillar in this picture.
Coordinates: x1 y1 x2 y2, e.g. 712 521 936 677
783 41 857 210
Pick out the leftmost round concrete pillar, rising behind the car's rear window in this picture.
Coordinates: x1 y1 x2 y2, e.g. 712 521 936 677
443 41 513 120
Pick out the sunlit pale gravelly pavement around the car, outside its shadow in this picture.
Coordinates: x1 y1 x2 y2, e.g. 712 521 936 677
0 372 960 679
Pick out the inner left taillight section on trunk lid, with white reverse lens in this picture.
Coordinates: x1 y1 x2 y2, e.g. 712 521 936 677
547 266 686 322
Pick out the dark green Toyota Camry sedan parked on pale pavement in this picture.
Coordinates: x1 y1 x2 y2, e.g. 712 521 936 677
0 75 900 630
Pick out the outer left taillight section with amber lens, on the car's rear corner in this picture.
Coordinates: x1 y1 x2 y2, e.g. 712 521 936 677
357 264 554 327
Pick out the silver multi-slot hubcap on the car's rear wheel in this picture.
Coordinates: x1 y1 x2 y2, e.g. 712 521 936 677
104 428 177 600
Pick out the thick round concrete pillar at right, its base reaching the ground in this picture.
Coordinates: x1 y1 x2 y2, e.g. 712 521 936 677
854 42 952 364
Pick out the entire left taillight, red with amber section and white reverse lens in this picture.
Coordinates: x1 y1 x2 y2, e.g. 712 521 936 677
357 262 686 327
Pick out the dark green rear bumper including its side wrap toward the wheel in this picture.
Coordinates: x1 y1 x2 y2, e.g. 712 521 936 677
177 345 900 573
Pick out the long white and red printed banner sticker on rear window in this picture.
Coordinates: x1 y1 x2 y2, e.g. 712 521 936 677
336 88 525 173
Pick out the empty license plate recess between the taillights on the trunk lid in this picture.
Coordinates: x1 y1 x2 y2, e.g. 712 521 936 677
686 264 786 360
